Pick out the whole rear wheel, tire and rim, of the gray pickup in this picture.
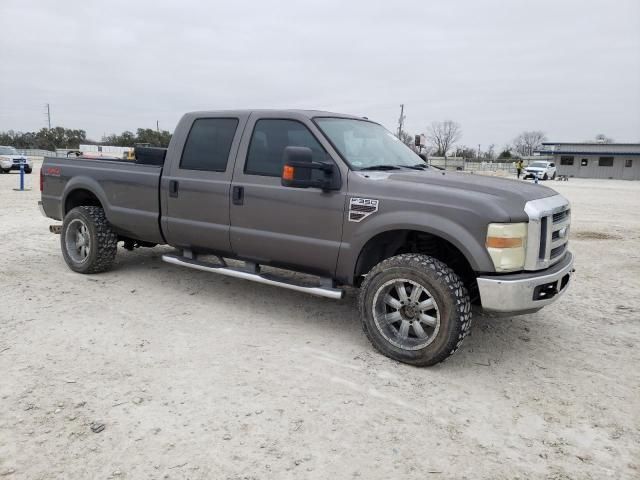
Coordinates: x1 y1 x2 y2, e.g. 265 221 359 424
60 207 118 273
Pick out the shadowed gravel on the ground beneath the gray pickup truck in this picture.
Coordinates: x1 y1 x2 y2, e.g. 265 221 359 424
112 247 556 370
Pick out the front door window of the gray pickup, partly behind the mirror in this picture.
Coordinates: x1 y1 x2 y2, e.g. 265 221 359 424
244 119 327 177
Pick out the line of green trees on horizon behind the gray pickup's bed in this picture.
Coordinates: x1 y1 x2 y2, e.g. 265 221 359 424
0 127 171 151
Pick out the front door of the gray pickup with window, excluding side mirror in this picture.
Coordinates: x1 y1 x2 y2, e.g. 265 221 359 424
231 113 347 276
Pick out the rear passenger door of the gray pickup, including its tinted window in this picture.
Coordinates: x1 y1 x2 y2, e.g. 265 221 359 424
161 114 248 253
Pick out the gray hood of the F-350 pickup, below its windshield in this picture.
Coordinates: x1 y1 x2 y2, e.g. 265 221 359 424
354 169 558 221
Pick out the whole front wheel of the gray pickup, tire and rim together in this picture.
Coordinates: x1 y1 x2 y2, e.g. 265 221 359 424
359 254 471 366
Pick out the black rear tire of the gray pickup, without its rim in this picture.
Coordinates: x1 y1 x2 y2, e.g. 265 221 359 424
60 206 118 273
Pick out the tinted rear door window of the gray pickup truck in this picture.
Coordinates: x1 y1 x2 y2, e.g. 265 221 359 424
180 118 238 172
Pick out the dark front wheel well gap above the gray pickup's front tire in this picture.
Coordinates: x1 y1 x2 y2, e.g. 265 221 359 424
354 230 478 300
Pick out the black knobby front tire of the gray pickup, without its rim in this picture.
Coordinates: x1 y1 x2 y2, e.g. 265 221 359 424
358 253 471 366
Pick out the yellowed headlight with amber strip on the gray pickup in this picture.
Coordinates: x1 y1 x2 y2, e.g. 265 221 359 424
486 223 527 272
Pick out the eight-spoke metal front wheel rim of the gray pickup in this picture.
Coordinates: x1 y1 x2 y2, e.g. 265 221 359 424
373 278 440 350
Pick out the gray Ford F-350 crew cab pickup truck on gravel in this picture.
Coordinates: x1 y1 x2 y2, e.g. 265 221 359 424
40 110 573 365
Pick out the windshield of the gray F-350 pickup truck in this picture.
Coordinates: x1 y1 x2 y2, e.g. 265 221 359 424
314 117 426 170
